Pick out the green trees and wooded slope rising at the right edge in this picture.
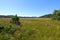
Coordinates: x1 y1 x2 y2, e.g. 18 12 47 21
39 10 60 20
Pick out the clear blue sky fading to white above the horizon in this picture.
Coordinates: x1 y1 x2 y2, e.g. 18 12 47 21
0 0 60 16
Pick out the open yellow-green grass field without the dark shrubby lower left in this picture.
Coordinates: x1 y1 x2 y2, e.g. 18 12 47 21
0 18 60 40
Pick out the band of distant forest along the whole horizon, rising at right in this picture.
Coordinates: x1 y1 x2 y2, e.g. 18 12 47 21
0 10 60 18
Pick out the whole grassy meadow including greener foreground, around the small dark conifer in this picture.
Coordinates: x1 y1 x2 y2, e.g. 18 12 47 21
0 18 60 40
